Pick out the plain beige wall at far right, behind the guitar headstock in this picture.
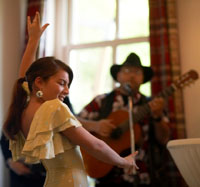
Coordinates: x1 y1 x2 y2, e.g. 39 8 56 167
177 0 200 138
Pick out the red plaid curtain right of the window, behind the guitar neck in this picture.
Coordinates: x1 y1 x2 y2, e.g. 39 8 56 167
149 0 185 139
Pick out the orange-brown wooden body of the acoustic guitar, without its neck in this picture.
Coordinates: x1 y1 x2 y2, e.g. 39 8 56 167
81 110 142 178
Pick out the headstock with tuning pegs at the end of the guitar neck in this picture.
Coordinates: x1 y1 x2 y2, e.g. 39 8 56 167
174 70 199 88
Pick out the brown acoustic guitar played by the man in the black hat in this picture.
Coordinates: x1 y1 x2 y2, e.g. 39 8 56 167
81 70 198 178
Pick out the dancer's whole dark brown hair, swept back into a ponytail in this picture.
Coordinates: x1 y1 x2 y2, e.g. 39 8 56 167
3 57 73 139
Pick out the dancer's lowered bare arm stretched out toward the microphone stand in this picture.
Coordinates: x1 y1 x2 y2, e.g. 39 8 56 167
62 127 138 170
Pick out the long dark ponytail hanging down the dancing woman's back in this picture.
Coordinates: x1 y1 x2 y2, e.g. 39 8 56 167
3 78 28 139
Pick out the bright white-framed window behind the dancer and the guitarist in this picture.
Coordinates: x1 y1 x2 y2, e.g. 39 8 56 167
46 0 150 113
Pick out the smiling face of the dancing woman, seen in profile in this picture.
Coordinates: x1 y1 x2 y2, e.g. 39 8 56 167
39 70 69 101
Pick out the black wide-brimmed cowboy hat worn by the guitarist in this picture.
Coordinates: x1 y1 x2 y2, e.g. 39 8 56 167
110 53 154 83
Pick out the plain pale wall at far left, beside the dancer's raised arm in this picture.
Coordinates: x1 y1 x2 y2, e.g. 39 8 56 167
0 0 26 187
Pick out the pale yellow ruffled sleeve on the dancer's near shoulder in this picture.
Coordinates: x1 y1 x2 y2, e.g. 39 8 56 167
22 99 81 163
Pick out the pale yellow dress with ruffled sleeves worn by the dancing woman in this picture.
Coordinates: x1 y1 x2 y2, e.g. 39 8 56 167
10 99 88 187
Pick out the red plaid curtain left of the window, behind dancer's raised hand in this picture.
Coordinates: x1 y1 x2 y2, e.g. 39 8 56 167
25 0 46 58
